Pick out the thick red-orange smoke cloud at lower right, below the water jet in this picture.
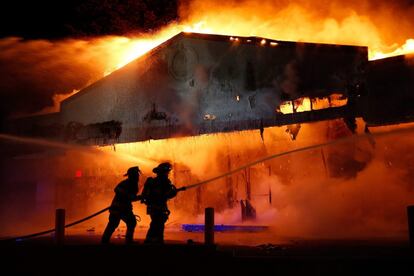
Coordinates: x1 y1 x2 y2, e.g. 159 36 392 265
176 123 414 244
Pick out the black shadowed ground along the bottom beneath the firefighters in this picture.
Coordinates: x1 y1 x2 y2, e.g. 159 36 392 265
0 235 414 276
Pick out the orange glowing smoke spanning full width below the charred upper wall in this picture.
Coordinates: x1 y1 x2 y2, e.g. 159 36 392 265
0 122 414 244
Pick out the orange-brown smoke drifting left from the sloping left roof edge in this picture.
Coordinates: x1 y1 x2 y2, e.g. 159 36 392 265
0 30 175 117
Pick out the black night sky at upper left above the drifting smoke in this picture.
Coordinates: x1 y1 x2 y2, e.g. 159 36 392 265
0 0 178 39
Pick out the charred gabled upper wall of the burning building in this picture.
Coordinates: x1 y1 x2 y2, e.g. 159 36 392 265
8 33 368 145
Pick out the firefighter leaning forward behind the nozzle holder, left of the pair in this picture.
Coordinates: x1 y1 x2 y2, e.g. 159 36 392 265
101 167 141 244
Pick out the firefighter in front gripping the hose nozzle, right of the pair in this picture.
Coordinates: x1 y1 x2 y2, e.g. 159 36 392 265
142 162 185 244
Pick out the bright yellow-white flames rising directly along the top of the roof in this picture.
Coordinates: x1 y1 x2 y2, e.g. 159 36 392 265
99 0 414 74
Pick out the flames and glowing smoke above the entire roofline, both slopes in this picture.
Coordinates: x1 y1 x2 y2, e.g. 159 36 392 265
5 0 414 115
